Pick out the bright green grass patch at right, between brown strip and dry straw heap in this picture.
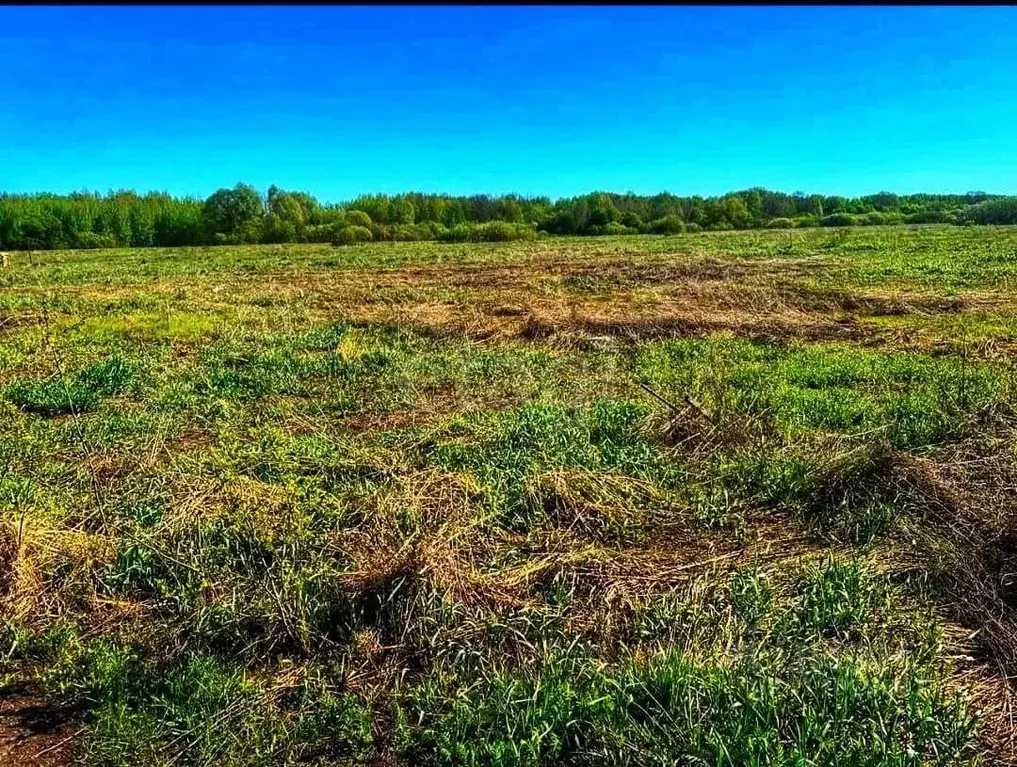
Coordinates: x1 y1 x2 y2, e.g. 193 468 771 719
636 340 1009 449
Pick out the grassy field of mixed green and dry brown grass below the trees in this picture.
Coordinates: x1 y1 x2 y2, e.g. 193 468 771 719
0 227 1017 767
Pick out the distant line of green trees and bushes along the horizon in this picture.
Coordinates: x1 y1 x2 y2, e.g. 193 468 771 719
0 184 1017 250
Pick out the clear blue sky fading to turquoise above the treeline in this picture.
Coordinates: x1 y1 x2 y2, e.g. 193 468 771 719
0 6 1017 200
